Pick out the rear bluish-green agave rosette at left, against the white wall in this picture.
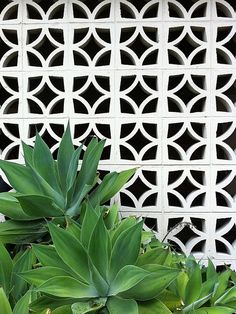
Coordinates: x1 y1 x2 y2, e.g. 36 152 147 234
0 125 136 244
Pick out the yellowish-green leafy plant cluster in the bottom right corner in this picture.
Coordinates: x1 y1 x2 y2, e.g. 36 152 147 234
160 256 236 314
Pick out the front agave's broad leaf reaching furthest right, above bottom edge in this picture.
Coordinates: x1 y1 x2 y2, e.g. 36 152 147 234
119 264 179 301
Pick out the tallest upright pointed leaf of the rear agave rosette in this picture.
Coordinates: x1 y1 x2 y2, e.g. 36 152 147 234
57 124 74 194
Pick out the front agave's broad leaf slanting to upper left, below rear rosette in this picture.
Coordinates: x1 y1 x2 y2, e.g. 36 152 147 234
48 223 90 282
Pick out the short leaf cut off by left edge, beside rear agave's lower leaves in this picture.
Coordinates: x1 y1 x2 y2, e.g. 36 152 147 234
0 192 33 220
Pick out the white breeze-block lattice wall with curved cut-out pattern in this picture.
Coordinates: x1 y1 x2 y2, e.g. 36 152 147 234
0 0 236 266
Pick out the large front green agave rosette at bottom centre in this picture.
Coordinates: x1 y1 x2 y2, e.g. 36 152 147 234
21 207 180 314
